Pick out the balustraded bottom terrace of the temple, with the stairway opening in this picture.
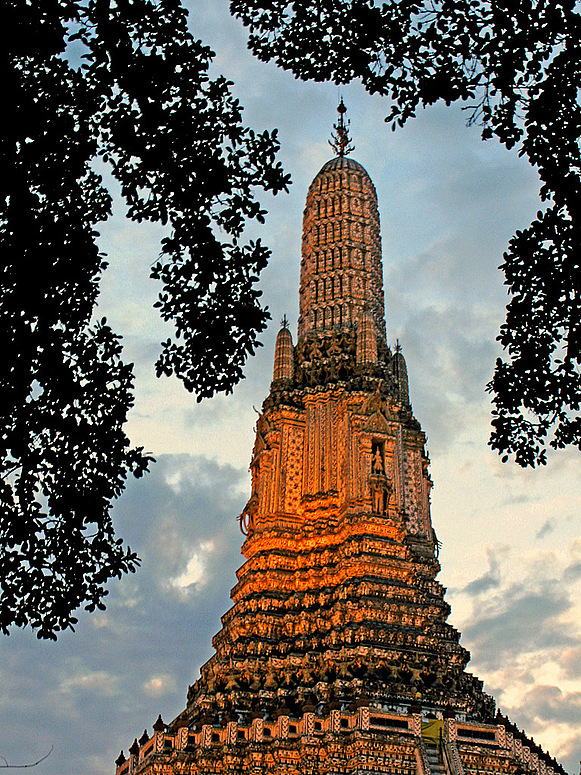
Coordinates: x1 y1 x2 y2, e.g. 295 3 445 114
116 705 565 775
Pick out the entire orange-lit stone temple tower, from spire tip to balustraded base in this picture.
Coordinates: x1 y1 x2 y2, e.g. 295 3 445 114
116 116 563 775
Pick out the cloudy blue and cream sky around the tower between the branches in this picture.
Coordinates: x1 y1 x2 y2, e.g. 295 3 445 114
0 0 581 775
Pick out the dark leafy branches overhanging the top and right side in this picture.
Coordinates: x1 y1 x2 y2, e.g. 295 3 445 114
231 0 581 466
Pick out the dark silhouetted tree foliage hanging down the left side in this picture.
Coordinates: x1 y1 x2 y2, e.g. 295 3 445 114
0 0 287 638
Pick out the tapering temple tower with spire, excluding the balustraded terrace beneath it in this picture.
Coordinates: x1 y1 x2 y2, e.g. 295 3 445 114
198 100 493 720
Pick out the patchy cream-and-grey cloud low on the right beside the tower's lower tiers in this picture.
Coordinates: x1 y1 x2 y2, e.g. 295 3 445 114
452 544 581 770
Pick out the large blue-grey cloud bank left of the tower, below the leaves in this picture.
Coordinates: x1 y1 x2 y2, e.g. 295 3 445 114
0 455 248 775
